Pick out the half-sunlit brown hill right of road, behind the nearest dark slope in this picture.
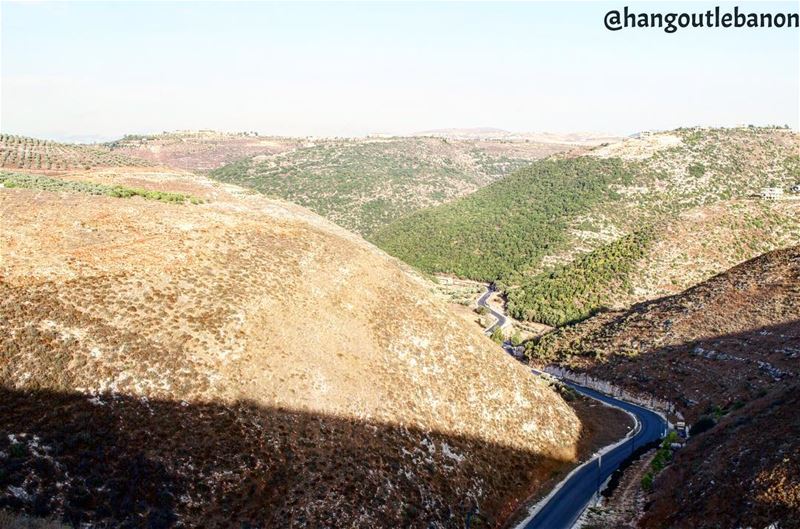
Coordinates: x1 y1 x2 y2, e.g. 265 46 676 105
528 246 800 419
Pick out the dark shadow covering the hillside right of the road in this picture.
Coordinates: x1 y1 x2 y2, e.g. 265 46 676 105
548 320 800 529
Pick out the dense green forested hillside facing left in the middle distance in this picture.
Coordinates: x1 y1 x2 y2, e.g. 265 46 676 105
373 157 633 281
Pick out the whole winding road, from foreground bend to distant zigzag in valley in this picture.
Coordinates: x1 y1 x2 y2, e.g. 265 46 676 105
478 286 667 529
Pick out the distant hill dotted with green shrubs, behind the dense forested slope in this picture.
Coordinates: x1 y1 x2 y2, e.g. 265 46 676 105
211 138 574 236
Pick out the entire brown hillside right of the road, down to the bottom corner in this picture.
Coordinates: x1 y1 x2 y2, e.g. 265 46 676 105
527 246 800 528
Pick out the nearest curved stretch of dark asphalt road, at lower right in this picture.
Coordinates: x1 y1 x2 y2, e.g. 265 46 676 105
517 381 667 529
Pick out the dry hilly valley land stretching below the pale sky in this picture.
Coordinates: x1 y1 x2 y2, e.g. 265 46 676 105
0 128 800 528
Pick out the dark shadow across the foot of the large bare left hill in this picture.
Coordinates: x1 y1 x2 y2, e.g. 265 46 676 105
0 388 566 528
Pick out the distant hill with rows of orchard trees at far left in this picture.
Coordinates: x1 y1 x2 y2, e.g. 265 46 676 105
0 134 151 171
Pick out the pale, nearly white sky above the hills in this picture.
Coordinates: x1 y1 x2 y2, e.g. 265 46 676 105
0 1 800 141
